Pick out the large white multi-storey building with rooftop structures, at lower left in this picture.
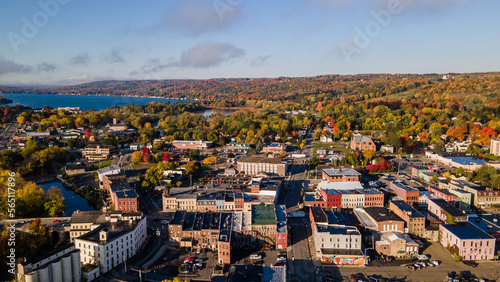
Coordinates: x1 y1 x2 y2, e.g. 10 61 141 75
75 212 147 273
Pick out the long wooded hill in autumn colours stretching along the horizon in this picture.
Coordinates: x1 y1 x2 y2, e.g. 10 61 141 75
0 73 500 107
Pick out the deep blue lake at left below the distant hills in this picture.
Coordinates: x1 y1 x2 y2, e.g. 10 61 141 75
0 93 180 111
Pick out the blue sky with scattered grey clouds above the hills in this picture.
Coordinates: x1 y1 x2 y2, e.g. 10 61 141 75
0 0 500 86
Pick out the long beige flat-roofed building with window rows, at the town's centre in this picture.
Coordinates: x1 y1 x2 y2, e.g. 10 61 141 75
237 157 287 176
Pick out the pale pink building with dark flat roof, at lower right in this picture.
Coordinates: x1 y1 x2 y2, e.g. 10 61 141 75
439 221 495 260
